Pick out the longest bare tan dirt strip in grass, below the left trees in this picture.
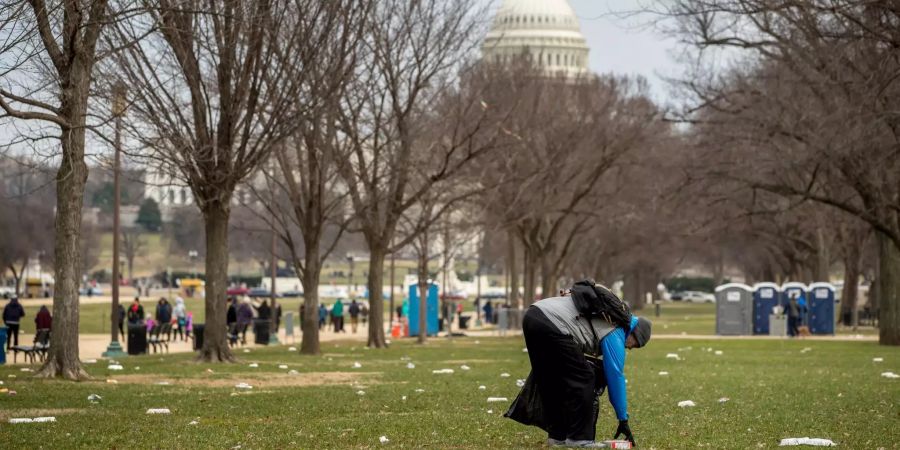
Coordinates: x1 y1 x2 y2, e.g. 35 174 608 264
106 372 381 388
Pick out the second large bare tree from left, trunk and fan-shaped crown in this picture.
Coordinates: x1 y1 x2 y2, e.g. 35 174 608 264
115 0 331 361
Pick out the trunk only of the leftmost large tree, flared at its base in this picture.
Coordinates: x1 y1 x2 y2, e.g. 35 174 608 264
37 122 90 380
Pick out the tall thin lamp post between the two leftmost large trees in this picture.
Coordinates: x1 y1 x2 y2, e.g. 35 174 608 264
103 81 125 357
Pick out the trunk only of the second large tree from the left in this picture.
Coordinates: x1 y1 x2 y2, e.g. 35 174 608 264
197 199 234 362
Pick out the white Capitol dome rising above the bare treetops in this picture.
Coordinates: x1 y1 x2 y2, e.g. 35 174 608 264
481 0 590 77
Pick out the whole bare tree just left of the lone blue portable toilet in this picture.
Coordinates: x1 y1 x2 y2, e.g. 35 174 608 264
340 0 502 348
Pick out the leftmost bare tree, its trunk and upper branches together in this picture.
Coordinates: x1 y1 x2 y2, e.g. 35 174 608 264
0 0 115 380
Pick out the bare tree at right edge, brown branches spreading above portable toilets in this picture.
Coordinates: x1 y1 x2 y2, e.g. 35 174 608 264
661 0 900 345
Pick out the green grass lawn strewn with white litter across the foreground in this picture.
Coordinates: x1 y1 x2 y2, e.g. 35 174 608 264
0 337 900 449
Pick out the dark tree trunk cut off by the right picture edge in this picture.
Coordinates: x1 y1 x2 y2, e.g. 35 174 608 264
877 232 900 345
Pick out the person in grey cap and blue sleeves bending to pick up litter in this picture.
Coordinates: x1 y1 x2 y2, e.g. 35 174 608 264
522 288 651 447
